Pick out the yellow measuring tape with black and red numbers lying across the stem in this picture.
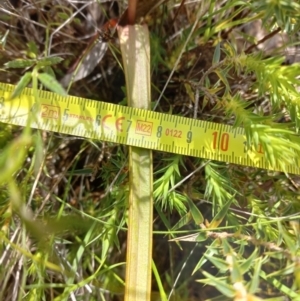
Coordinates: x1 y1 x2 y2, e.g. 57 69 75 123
0 83 300 174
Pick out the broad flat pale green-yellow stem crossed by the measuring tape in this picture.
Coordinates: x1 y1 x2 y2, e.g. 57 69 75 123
118 25 153 301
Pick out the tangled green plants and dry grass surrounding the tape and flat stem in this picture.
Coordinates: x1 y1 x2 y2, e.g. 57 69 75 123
0 0 300 301
